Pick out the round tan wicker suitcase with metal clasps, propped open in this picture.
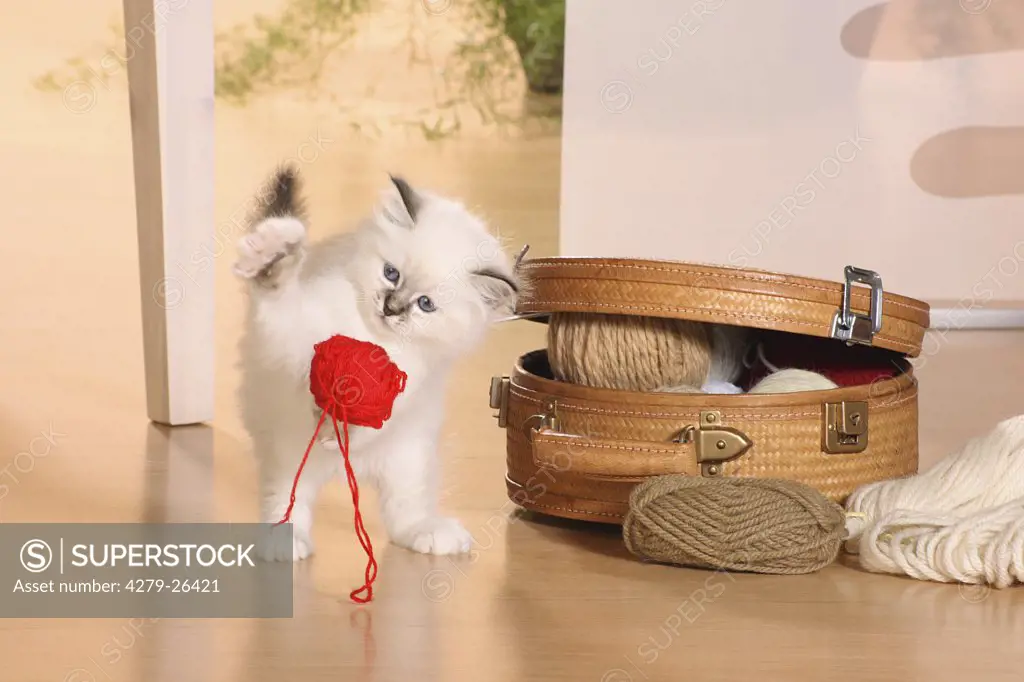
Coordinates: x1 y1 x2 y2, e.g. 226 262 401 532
490 258 929 523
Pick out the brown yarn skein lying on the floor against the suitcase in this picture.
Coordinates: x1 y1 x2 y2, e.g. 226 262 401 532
623 475 846 574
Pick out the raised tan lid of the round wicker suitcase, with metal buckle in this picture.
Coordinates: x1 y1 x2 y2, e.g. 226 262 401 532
515 256 930 357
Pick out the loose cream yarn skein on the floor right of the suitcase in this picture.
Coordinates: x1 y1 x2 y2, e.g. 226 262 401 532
846 416 1024 588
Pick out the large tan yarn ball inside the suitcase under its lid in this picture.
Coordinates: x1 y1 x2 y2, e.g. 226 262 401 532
548 312 712 391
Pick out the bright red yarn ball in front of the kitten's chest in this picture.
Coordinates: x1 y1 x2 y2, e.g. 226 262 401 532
309 336 408 429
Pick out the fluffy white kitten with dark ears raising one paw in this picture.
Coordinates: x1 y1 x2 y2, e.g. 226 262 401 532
234 164 520 561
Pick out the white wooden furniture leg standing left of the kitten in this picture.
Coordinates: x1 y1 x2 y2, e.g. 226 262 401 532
123 0 215 425
